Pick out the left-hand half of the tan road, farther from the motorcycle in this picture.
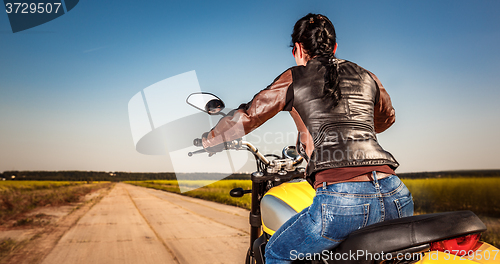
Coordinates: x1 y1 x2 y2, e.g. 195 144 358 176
43 183 180 264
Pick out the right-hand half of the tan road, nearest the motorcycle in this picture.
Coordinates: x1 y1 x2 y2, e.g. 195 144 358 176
124 185 249 264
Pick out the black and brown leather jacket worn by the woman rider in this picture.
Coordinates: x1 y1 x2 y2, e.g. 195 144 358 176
203 58 399 182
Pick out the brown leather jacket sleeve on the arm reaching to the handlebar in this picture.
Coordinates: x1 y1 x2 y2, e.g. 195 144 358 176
203 70 292 148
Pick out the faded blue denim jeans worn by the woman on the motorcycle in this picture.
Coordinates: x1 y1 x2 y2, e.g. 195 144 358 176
266 172 413 264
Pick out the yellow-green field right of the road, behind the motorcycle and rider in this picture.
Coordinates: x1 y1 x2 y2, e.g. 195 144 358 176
128 177 500 247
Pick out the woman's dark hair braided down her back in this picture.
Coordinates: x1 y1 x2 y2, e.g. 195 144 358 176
291 13 342 107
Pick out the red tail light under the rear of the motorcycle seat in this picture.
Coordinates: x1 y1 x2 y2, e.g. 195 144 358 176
430 234 481 256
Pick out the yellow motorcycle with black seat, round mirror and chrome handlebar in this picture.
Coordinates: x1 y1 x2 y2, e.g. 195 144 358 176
186 92 500 264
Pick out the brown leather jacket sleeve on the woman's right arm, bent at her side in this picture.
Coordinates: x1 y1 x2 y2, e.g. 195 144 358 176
370 72 396 133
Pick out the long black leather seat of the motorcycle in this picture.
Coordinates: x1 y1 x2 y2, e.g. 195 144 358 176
332 211 486 254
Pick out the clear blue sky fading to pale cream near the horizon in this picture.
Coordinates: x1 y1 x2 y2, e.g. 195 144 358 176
0 0 500 172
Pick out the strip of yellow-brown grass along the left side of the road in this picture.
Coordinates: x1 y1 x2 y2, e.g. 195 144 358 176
0 181 111 226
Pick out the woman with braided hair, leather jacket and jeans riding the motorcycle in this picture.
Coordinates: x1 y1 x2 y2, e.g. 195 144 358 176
203 14 413 264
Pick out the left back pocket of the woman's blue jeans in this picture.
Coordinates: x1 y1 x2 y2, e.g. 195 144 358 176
321 204 370 242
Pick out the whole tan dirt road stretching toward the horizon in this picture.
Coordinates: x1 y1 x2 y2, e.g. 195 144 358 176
42 183 249 264
